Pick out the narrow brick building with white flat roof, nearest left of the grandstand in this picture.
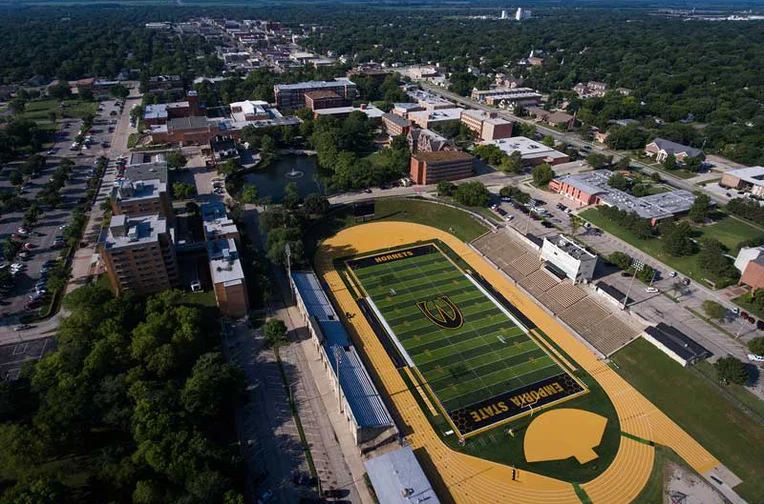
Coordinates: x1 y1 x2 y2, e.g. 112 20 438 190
207 238 249 318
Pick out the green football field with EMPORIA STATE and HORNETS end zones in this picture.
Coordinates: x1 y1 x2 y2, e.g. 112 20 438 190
346 244 585 435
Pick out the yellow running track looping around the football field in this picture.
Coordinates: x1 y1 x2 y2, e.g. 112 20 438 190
316 222 719 504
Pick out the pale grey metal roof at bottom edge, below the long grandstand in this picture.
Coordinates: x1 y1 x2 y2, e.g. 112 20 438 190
364 446 440 504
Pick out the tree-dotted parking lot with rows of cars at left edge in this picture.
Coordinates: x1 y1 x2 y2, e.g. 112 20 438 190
0 100 120 330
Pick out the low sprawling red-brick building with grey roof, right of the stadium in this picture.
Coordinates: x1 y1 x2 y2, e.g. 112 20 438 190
549 170 695 225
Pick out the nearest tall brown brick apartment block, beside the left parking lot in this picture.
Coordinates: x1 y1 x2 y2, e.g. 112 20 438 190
100 214 179 295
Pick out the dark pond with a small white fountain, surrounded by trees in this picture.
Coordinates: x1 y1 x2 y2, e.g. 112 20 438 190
244 155 330 203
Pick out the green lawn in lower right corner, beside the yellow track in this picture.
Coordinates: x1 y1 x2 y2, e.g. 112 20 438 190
612 339 764 502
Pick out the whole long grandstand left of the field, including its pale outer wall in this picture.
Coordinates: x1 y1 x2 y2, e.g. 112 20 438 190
290 271 397 445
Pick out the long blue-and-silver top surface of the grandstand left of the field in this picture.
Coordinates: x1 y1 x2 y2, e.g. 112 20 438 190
292 272 393 427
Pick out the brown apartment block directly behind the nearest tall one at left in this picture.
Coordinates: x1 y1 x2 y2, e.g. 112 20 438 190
111 179 175 224
